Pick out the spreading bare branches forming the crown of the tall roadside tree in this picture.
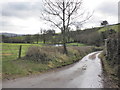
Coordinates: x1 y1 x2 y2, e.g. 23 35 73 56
41 0 92 29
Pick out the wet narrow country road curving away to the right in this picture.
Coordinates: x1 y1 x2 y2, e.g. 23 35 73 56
3 52 103 88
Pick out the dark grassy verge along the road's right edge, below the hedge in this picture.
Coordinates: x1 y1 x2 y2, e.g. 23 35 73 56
100 52 119 88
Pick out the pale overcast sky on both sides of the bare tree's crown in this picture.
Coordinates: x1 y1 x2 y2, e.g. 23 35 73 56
0 0 119 34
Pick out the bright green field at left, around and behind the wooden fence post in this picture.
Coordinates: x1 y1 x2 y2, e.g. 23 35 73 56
2 43 42 61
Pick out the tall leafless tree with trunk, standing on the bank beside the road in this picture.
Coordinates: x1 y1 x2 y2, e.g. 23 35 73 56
41 0 91 54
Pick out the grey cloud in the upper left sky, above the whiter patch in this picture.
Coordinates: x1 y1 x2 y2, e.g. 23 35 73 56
2 2 42 17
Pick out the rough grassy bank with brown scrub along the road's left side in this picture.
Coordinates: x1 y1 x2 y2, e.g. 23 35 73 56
2 46 94 79
